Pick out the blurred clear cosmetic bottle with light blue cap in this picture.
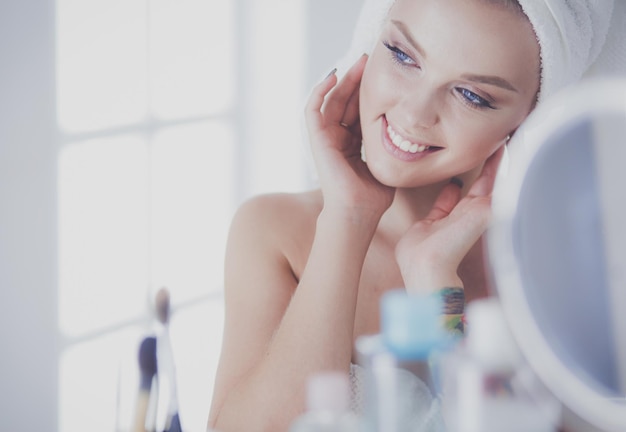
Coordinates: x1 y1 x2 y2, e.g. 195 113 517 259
356 289 452 432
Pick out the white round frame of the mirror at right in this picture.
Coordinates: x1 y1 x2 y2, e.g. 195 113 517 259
486 77 626 432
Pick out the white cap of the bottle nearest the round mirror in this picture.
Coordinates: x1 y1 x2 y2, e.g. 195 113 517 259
465 297 521 372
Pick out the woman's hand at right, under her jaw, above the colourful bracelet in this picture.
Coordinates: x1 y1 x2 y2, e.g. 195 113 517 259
395 147 504 292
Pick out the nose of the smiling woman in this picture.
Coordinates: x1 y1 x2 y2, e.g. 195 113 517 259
398 86 440 129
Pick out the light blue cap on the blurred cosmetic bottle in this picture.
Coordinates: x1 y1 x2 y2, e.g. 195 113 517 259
381 289 447 360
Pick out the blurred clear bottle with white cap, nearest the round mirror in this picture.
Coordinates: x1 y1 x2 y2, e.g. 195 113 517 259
439 297 560 432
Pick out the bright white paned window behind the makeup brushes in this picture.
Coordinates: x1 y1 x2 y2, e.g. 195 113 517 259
56 0 308 431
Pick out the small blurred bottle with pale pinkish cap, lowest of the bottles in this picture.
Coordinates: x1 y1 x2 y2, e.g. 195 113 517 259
289 371 360 432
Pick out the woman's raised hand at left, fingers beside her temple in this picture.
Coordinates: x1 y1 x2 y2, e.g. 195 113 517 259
305 55 394 218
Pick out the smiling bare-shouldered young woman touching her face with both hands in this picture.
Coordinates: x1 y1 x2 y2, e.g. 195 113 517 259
209 0 612 432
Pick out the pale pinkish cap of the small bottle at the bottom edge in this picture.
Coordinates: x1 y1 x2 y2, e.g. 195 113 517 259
307 371 350 413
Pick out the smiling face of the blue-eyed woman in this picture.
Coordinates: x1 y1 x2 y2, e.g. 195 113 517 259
360 0 539 187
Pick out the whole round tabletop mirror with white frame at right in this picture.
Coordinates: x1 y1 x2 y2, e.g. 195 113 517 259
487 78 626 432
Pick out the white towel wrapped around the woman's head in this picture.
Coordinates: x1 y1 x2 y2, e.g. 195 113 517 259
337 0 626 104
